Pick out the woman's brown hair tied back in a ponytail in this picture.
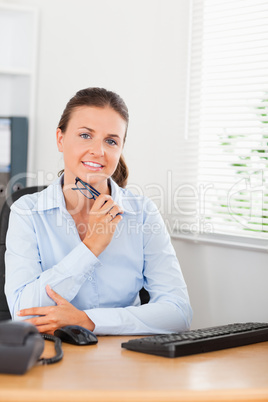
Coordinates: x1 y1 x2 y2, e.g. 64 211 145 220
58 87 129 187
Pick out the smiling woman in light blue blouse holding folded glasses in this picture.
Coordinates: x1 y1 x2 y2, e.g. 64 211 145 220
5 88 192 335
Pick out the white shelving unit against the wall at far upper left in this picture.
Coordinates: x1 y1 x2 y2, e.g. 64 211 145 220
0 3 38 176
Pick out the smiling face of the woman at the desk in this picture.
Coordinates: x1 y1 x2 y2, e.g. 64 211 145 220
57 106 126 192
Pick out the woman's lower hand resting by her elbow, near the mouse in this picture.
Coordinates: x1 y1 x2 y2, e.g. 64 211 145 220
17 285 95 335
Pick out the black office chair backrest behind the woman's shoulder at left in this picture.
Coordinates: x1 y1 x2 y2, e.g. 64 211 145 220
0 186 46 321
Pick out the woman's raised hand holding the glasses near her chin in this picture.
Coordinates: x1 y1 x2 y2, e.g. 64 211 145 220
83 194 123 257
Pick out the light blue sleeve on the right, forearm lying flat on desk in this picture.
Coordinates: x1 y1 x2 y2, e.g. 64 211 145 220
86 200 192 335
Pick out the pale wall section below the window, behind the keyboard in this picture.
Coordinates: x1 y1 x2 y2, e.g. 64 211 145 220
176 239 268 328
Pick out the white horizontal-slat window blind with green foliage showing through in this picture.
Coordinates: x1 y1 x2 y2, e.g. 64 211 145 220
171 0 268 239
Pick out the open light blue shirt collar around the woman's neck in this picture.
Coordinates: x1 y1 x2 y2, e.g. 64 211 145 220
33 175 139 215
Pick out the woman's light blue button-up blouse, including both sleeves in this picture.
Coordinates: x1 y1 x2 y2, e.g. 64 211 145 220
5 178 192 335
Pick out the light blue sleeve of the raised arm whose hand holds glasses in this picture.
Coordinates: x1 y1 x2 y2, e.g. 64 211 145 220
5 200 101 319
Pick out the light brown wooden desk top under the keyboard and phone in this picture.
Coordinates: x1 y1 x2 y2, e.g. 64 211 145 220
0 337 268 402
